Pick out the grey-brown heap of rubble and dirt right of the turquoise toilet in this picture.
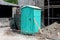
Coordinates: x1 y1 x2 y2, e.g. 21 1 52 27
37 22 60 40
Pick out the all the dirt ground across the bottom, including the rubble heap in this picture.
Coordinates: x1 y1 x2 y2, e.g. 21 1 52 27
0 22 60 40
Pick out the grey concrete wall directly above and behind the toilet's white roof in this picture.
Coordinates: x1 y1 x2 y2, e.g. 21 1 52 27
18 0 44 9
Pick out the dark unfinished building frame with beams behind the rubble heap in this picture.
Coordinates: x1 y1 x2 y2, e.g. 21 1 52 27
44 0 60 26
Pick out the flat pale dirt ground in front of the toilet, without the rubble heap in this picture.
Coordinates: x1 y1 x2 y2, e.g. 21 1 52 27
0 27 38 40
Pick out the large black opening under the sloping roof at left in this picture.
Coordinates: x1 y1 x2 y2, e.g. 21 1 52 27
0 5 12 18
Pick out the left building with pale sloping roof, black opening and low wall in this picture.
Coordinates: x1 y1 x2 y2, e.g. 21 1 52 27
0 0 18 26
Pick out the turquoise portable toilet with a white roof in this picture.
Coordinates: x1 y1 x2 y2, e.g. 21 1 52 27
21 5 42 34
